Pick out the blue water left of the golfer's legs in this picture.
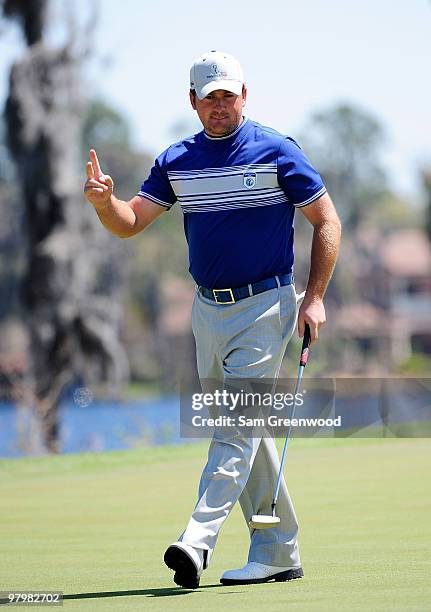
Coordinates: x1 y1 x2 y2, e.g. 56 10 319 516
0 397 190 457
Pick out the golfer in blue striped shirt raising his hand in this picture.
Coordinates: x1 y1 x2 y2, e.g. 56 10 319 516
85 51 341 588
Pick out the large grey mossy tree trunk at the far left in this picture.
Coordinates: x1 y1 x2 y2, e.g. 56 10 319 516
3 0 128 452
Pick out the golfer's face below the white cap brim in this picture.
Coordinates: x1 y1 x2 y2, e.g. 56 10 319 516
190 85 247 136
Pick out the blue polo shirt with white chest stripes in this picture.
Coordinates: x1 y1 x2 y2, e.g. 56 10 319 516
139 119 326 289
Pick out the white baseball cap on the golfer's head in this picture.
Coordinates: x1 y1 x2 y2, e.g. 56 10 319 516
190 51 244 100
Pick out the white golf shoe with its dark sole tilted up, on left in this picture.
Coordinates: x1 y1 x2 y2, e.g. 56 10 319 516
163 542 208 589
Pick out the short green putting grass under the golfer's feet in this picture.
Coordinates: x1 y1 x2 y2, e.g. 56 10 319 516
0 439 431 612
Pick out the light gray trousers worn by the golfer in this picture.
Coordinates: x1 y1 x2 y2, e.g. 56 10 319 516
180 285 301 568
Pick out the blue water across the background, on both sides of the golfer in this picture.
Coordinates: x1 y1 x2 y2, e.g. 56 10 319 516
0 379 431 457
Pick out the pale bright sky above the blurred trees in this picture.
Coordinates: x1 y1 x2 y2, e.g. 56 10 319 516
0 0 431 202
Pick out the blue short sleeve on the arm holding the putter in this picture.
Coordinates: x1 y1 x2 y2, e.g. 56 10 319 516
277 138 326 208
